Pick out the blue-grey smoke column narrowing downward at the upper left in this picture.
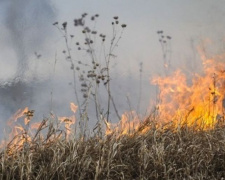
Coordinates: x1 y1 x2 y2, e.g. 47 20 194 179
4 0 55 79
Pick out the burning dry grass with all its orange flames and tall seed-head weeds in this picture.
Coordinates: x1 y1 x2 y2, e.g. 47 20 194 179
0 13 225 180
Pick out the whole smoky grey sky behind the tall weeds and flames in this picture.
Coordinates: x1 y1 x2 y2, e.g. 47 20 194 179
0 0 225 132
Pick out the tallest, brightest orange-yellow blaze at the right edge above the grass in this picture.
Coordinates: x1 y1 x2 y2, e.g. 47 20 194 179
152 52 225 130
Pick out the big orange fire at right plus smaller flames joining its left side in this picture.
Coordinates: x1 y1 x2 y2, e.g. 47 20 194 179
105 52 225 137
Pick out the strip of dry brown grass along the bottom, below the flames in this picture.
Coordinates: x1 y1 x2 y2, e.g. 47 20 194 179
0 120 225 180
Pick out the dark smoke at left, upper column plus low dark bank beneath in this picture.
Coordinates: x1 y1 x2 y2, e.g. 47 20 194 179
0 0 56 124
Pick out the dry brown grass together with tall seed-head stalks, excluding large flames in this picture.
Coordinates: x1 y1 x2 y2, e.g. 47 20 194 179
0 13 225 180
